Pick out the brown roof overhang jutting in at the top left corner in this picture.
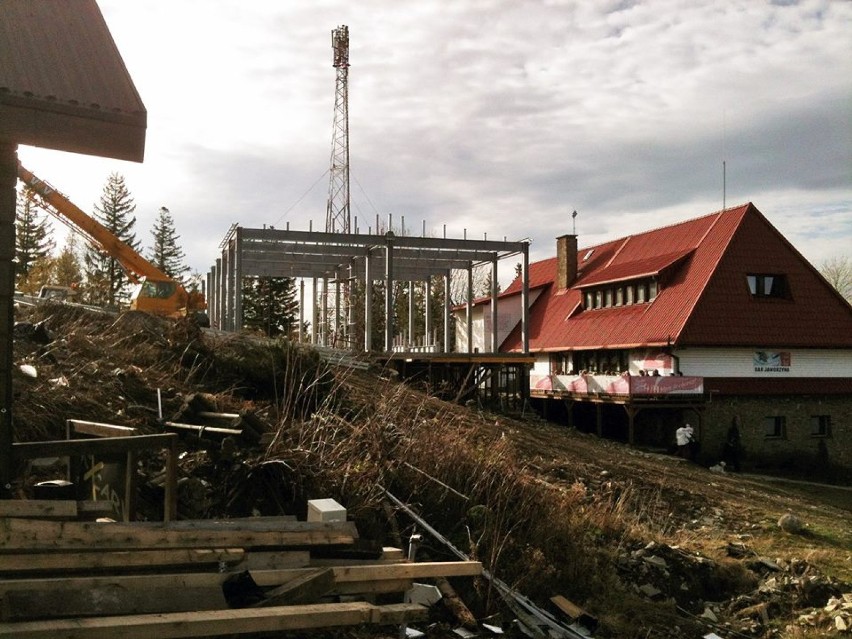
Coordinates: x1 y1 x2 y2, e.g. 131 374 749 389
0 0 147 162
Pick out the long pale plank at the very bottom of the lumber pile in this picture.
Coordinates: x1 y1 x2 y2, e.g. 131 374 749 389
0 602 428 639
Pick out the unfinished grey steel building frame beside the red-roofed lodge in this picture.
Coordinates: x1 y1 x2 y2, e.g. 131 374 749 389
207 224 529 354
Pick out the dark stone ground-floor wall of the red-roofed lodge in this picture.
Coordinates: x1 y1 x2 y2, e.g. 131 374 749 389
701 395 852 479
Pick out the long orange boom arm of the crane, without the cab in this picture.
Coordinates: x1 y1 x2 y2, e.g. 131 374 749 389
18 162 174 284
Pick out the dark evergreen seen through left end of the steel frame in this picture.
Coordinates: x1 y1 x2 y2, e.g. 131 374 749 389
242 277 299 337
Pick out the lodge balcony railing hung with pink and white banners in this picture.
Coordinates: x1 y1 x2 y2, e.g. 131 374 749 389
530 374 704 398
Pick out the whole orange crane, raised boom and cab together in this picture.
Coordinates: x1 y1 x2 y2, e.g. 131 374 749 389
18 162 207 317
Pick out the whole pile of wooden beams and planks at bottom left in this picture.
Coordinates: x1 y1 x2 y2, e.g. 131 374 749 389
0 500 482 639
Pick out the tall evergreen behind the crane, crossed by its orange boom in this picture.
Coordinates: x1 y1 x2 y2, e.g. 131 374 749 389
83 173 140 306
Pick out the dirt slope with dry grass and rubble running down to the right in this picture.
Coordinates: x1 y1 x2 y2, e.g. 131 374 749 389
8 305 852 638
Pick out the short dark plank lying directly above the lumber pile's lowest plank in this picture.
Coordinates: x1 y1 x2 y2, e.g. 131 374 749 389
0 586 228 621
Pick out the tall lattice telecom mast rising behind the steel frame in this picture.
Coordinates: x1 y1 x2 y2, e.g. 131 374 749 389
325 25 350 233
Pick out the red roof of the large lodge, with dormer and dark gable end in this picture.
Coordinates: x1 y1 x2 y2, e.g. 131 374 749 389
501 204 852 351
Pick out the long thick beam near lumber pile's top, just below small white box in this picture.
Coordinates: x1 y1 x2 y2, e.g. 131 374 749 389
0 516 358 552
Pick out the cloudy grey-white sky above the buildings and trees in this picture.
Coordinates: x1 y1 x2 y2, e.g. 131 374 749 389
19 0 852 280
